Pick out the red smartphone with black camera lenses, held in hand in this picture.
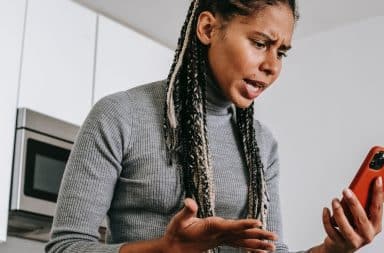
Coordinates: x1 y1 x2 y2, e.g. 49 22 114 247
332 146 384 226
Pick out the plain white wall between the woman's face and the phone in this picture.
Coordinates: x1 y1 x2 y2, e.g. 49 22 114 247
256 16 384 253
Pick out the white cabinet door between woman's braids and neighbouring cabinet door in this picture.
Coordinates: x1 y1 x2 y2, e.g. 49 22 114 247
94 16 174 102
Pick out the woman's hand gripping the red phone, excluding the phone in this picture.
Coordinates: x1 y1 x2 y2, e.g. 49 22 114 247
322 178 384 253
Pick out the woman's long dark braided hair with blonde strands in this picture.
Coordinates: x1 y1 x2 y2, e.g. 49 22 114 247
164 0 298 237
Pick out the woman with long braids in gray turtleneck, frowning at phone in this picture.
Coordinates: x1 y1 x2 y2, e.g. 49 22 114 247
46 0 383 253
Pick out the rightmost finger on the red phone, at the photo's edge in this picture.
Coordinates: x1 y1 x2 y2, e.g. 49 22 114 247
369 177 384 233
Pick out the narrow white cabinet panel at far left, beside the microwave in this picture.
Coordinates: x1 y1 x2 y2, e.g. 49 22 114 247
0 0 26 242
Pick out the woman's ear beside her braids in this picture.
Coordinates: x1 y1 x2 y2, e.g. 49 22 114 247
196 11 217 46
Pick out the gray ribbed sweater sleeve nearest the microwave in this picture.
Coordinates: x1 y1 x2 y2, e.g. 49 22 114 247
45 93 131 253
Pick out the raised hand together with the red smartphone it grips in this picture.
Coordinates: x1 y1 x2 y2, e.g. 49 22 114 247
319 147 384 252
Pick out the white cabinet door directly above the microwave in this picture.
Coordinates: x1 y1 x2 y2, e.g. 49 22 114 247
19 0 97 124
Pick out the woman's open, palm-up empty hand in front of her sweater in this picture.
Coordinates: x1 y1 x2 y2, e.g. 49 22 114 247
162 199 277 253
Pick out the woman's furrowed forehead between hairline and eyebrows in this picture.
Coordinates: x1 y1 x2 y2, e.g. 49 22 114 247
227 4 295 44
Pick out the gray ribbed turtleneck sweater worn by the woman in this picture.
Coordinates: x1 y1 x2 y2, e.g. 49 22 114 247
46 81 306 253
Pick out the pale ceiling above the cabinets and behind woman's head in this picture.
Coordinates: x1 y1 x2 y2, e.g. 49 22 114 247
74 0 384 49
